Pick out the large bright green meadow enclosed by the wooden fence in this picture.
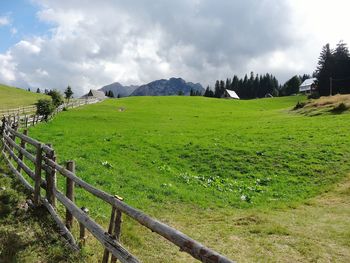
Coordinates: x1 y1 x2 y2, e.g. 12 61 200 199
22 96 350 262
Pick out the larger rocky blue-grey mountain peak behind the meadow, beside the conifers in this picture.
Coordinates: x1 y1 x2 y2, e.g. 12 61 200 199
130 78 204 96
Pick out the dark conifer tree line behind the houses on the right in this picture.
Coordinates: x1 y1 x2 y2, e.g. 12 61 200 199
204 41 350 99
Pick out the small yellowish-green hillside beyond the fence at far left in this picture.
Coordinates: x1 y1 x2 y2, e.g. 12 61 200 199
0 84 45 110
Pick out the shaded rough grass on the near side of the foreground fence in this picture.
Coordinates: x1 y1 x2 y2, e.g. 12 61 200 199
0 157 84 262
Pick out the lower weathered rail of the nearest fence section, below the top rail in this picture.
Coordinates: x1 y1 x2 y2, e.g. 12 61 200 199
55 189 139 263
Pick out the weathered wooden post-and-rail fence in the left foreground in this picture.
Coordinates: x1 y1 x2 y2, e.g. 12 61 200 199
1 119 233 263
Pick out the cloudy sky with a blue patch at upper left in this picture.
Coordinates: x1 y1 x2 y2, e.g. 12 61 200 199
0 0 350 95
